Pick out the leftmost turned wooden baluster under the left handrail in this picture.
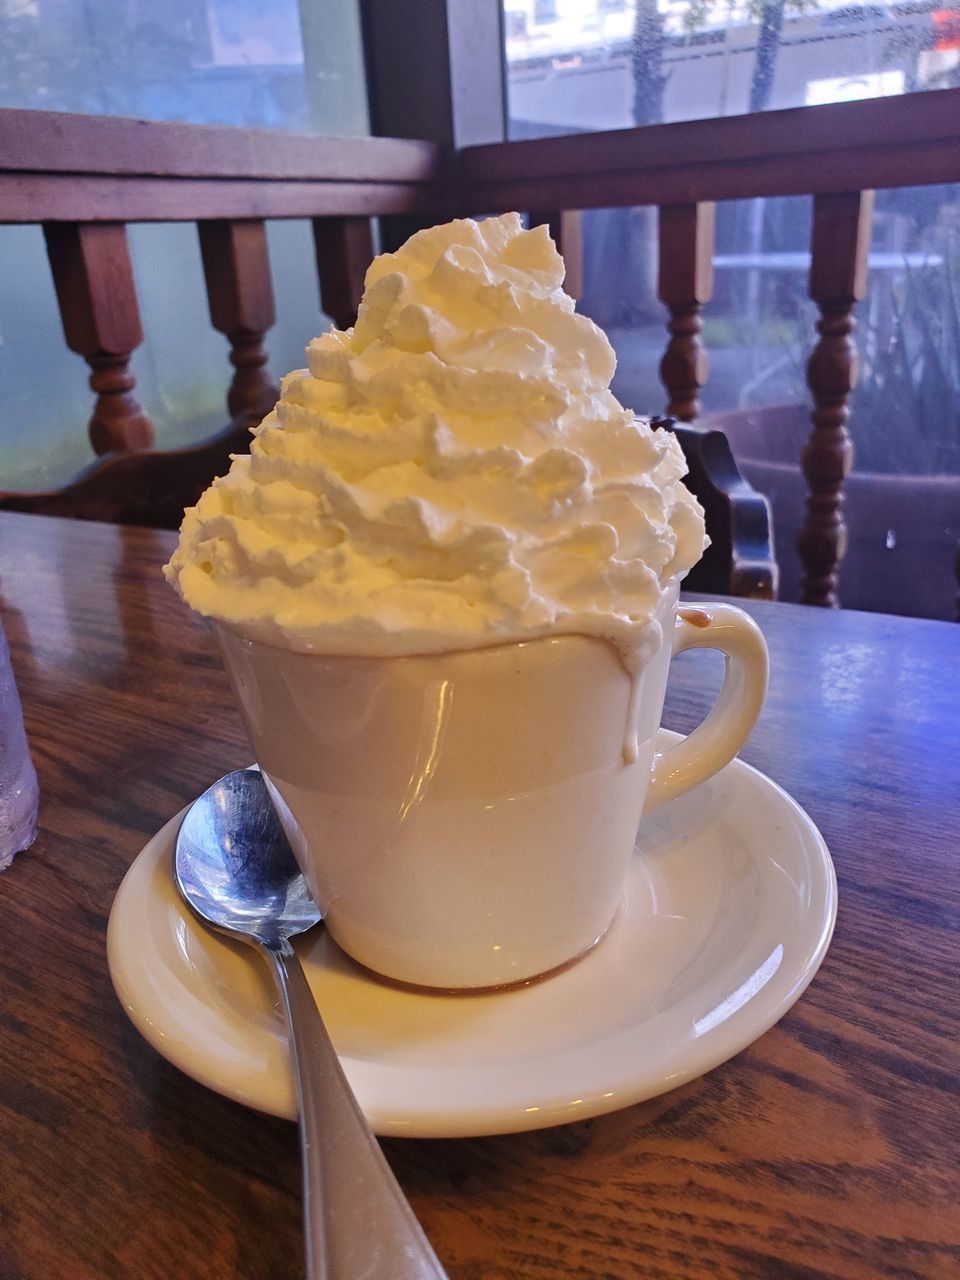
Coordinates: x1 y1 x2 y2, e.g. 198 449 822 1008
44 223 154 453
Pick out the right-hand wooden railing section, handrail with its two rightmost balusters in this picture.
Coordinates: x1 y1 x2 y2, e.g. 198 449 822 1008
460 90 960 605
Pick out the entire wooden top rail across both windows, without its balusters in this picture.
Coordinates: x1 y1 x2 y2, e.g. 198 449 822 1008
9 90 960 223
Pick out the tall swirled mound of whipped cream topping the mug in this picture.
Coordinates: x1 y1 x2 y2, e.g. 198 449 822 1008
165 214 705 667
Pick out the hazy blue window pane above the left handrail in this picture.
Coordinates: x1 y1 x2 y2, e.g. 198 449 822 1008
0 0 367 133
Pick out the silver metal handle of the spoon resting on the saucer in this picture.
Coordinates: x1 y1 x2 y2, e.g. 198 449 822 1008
264 940 447 1280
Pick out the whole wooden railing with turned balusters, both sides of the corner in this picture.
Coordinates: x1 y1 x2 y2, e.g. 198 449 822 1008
0 90 960 604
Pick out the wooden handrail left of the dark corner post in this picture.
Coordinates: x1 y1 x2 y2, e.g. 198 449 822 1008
0 110 445 223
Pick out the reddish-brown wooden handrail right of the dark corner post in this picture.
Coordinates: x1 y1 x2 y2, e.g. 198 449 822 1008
458 88 960 211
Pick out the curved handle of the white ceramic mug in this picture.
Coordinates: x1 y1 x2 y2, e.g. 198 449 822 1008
644 603 769 814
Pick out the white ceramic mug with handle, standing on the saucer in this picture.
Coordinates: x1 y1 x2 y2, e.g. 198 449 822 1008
219 590 767 988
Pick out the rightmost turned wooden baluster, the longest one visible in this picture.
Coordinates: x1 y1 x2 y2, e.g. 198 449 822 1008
796 191 873 608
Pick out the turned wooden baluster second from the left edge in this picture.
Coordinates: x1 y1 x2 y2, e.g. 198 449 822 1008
197 218 279 417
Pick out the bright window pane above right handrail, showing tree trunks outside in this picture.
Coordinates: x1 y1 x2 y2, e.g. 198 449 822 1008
503 0 960 137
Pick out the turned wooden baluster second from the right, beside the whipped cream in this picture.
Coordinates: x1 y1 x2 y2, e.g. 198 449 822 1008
658 204 714 422
